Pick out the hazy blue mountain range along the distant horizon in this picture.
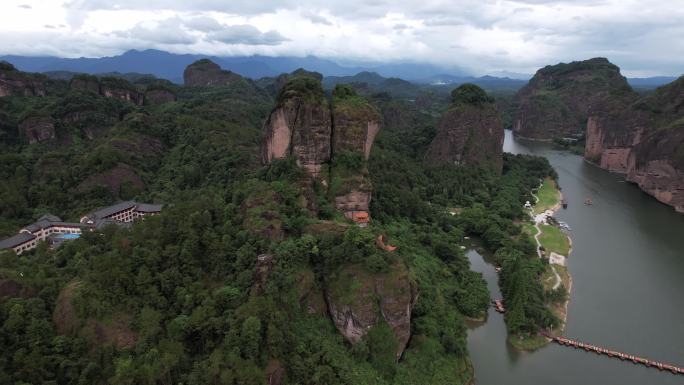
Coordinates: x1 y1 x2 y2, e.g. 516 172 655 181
0 49 676 89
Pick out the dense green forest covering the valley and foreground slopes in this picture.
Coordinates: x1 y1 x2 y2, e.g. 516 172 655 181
0 67 555 384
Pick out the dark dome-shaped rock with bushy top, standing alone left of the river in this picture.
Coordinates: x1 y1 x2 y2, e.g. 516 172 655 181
425 84 504 173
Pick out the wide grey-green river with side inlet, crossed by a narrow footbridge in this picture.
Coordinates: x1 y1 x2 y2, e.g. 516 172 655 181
468 130 684 385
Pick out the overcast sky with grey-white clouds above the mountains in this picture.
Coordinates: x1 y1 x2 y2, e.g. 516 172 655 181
0 0 684 77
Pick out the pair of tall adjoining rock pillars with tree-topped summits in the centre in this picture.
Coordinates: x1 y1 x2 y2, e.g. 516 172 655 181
262 77 381 221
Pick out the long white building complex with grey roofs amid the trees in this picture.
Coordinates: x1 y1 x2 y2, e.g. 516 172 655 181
0 201 162 254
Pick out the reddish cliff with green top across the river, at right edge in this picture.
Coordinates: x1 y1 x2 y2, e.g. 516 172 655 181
584 77 684 213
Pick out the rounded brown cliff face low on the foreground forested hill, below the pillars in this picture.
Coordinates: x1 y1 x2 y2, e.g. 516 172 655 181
326 263 418 358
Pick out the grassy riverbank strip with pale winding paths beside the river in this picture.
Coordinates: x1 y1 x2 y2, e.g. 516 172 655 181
508 178 572 351
